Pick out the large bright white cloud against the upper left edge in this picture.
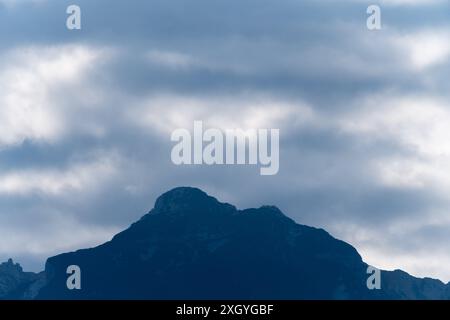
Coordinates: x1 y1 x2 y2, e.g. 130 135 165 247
0 45 102 148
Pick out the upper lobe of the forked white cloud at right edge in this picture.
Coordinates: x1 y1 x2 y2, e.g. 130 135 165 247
340 93 450 156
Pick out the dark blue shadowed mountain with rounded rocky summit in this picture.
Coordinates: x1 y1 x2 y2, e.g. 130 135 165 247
3 188 450 300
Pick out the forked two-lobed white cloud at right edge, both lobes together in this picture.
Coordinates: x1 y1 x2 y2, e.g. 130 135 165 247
339 94 450 192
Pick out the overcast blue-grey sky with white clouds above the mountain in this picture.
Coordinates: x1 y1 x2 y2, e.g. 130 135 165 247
0 0 450 282
